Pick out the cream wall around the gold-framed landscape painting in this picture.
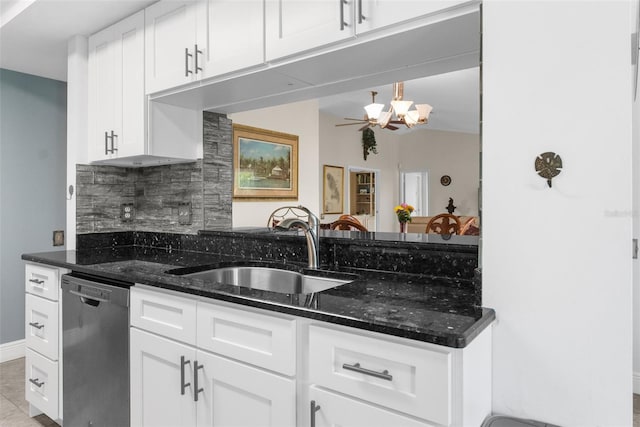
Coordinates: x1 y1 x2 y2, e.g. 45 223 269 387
229 100 320 227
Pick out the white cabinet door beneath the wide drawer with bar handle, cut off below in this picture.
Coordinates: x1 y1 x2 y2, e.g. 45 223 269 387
309 386 431 427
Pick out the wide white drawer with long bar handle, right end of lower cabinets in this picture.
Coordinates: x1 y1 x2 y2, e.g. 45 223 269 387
309 325 451 425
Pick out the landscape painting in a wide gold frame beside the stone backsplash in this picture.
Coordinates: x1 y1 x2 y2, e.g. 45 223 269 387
233 124 298 200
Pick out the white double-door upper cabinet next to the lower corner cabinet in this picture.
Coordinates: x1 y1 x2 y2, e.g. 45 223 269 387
145 0 264 93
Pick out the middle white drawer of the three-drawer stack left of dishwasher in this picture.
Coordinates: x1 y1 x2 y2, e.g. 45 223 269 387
25 294 59 360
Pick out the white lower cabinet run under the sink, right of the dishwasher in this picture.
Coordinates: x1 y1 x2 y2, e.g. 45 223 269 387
130 285 491 427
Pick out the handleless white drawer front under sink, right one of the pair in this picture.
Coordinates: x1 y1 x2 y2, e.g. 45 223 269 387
198 301 296 376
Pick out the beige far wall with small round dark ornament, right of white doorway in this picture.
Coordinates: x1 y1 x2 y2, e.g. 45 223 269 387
399 129 480 216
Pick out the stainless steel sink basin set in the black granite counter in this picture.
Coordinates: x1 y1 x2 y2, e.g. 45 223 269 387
184 266 352 294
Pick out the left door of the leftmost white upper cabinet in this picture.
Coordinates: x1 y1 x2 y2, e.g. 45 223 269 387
88 27 118 161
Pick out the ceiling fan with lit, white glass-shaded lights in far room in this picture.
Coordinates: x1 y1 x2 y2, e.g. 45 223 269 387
336 82 433 131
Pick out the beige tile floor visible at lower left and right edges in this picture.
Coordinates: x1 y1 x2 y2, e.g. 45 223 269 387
0 358 640 427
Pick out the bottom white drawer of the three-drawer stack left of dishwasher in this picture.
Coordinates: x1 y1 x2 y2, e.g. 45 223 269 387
25 348 59 420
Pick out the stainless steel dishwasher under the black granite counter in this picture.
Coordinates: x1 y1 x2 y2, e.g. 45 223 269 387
61 273 130 427
